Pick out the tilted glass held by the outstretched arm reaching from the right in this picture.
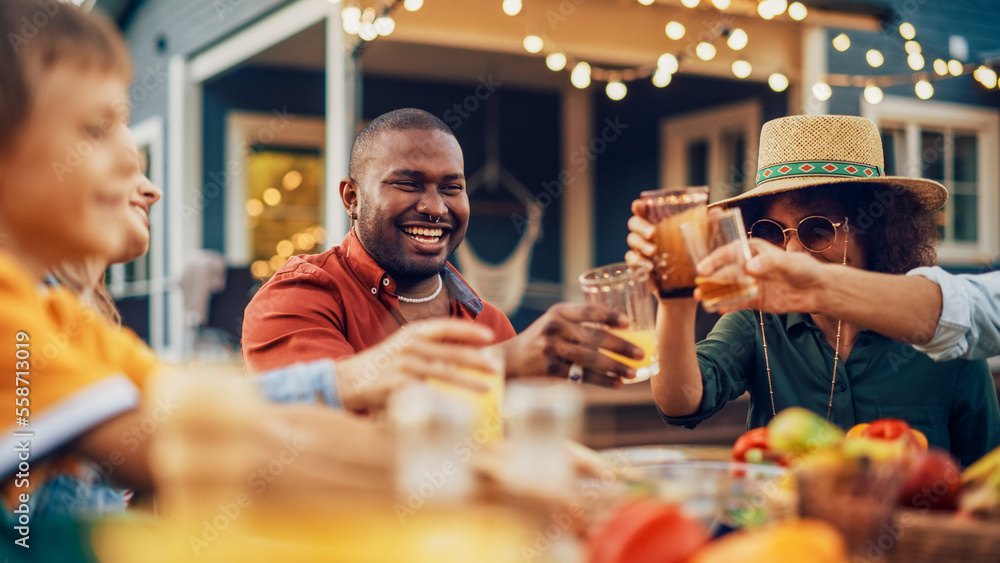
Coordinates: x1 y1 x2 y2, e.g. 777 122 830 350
680 209 757 312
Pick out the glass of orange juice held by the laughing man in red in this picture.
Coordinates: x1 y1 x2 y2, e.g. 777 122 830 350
580 262 659 383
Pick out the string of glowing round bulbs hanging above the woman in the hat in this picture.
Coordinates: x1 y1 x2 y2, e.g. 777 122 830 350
502 0 997 104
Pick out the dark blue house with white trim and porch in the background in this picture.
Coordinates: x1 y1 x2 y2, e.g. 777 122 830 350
90 0 1000 359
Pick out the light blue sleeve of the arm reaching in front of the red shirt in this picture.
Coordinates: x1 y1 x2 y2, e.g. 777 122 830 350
254 360 342 408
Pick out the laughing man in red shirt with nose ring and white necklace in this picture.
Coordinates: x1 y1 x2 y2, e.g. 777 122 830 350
243 109 642 400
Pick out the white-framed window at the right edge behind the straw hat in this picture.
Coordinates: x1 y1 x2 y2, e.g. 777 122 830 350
862 96 1000 265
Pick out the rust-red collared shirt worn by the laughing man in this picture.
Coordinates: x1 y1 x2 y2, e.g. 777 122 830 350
243 230 515 372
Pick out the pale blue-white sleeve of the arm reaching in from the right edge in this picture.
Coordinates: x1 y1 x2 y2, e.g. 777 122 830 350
907 266 1000 361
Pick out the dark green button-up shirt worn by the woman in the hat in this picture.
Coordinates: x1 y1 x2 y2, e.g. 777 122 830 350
661 311 1000 466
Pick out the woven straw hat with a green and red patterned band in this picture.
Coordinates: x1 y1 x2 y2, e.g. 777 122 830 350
711 115 948 210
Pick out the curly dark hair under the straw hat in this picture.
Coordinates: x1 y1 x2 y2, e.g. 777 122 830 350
736 182 940 274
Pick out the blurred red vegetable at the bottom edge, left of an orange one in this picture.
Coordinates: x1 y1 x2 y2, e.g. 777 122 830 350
587 500 711 563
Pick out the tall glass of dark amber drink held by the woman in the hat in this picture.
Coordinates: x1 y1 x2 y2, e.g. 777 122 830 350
640 186 708 298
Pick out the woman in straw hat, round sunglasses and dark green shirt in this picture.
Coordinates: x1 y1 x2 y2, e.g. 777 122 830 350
626 116 1000 465
